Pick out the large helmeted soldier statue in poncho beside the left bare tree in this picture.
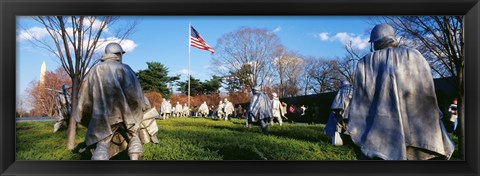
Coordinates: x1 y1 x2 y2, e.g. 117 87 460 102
72 43 147 160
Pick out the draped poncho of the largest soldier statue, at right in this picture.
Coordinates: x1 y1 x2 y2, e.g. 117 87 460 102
347 48 454 160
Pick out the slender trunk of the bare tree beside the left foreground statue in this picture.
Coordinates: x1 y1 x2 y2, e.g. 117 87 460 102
67 75 81 150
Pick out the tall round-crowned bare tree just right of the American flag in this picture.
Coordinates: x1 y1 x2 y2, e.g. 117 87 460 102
213 27 281 91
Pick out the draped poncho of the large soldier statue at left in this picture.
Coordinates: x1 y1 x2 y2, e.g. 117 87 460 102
75 55 146 146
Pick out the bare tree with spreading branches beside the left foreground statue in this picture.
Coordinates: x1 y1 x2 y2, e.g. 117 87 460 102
27 16 136 150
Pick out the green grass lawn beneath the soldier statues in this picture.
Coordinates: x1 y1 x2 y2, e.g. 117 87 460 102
16 118 459 160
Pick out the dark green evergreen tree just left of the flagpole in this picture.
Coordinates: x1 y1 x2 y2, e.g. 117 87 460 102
137 62 180 97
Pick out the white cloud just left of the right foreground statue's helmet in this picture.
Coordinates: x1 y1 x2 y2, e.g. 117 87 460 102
315 32 370 49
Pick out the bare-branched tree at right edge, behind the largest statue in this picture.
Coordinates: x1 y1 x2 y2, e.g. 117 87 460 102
379 16 465 156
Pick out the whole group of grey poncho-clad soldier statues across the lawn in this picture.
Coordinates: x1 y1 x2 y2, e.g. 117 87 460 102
54 24 454 160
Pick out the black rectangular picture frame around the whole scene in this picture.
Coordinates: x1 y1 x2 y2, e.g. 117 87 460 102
0 0 480 176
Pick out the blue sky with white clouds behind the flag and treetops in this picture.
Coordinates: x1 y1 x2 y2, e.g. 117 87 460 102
16 16 373 107
